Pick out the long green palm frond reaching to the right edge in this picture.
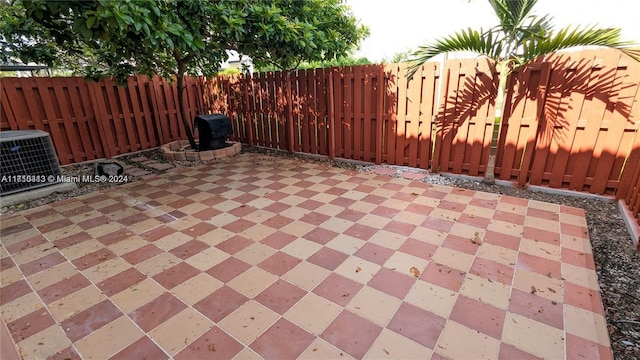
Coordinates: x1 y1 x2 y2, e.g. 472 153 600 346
519 26 640 62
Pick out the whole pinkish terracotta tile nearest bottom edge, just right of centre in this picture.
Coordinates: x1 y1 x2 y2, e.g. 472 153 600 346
321 310 382 359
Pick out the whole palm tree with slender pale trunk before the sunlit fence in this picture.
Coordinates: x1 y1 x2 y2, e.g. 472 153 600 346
408 0 640 184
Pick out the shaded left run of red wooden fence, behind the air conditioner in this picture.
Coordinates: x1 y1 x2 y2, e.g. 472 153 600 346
0 76 202 165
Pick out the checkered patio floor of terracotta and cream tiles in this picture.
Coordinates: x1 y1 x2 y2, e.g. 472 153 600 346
0 154 611 359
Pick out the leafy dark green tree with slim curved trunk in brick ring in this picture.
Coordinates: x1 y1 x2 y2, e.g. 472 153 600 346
0 0 368 146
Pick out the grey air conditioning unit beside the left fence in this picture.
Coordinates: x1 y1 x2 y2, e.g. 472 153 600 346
0 130 62 195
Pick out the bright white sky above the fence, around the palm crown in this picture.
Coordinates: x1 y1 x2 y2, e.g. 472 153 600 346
346 0 640 61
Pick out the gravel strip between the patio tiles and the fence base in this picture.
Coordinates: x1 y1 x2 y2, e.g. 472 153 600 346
0 147 640 359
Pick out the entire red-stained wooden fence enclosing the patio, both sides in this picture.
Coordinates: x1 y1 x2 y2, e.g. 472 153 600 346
0 50 640 224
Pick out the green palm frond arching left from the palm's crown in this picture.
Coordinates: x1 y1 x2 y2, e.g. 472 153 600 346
408 28 502 80
